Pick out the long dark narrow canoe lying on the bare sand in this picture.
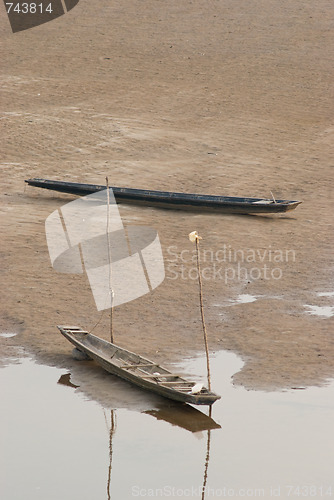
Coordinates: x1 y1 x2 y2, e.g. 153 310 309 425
25 178 301 214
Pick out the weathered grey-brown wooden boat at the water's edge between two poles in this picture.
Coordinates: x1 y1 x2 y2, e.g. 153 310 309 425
58 326 220 405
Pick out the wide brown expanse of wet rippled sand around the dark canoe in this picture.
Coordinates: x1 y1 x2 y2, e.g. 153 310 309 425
0 0 334 389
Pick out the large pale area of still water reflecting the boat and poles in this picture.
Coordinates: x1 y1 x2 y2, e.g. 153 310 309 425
0 352 334 500
